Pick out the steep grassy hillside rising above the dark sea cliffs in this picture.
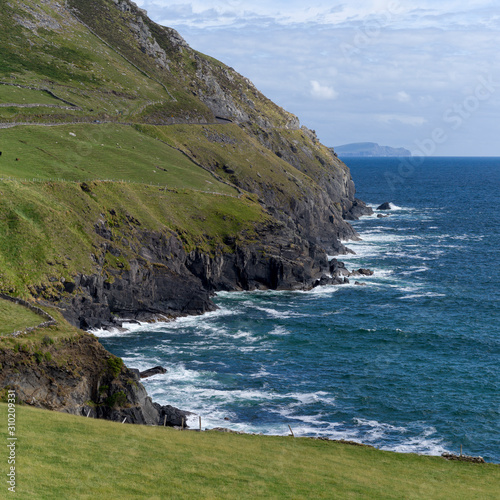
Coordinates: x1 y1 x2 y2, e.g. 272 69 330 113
0 0 348 299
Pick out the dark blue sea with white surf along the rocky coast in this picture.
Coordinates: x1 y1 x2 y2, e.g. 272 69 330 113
95 158 500 462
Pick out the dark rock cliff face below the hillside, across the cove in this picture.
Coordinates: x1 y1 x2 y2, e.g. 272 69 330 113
55 218 350 329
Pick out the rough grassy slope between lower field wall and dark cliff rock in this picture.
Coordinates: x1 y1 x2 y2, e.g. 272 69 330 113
0 176 269 299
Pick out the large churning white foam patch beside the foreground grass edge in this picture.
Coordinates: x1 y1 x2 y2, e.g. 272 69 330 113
139 364 450 455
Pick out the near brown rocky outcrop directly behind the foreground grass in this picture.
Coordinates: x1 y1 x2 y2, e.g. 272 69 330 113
0 334 187 426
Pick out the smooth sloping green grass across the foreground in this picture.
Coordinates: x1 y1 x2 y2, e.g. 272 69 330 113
0 404 500 500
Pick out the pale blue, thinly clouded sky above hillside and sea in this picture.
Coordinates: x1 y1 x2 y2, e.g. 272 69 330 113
136 0 500 156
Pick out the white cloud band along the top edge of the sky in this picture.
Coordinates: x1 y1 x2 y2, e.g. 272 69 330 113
136 0 500 30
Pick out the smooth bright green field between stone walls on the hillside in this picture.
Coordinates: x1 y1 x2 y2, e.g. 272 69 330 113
0 124 237 195
